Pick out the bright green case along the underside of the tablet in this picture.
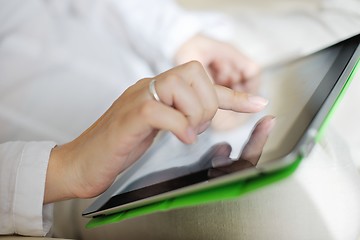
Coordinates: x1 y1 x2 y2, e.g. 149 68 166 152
86 59 360 228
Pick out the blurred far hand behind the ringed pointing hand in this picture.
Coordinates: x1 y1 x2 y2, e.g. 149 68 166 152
175 35 260 130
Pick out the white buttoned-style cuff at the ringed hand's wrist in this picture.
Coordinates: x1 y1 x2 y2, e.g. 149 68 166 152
13 142 55 236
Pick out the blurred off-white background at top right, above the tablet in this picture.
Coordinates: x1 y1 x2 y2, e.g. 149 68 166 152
178 0 360 65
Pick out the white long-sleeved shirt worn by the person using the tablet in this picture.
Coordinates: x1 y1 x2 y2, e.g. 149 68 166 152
0 0 228 236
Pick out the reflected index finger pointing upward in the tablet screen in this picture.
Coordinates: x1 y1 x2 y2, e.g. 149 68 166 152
240 116 275 165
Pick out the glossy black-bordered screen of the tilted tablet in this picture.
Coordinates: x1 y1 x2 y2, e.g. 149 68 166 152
83 34 359 216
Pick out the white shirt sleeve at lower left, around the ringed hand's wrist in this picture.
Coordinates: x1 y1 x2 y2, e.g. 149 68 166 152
0 142 55 236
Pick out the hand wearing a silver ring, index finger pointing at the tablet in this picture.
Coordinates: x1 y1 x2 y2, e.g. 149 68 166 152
44 62 267 203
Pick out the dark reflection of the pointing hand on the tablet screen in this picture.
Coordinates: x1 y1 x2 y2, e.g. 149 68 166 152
119 115 275 189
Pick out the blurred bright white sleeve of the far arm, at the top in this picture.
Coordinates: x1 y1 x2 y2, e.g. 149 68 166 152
111 0 233 72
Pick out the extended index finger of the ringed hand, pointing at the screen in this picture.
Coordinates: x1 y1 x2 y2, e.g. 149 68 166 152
215 85 269 113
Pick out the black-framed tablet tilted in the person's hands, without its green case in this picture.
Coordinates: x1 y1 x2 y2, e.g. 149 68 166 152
83 32 360 217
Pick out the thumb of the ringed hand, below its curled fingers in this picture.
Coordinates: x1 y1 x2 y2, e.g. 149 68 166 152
141 101 196 144
